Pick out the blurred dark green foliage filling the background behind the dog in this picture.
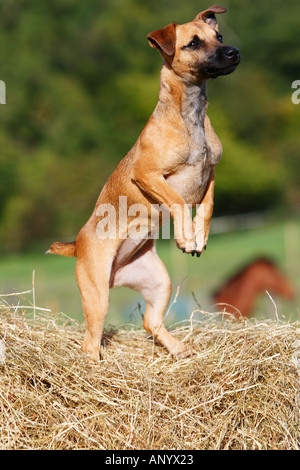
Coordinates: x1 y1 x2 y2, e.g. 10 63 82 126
0 0 300 251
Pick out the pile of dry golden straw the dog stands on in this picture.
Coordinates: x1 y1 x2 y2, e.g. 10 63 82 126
0 292 300 450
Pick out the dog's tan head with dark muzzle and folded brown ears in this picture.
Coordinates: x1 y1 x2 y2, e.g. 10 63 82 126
147 5 240 83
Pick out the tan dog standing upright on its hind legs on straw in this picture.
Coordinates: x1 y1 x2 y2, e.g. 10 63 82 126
49 5 240 360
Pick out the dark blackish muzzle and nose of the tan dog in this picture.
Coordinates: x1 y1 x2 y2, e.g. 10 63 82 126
200 46 241 78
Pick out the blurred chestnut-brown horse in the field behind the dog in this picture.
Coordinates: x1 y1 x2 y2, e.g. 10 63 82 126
213 258 295 318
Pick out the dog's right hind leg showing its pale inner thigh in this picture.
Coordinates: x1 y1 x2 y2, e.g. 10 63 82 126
112 240 190 356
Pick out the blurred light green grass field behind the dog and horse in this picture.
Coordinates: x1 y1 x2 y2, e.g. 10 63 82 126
0 220 300 325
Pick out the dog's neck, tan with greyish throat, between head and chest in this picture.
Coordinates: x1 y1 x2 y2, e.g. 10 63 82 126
159 65 207 128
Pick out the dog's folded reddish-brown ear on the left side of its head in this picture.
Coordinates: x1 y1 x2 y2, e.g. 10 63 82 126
147 23 178 62
